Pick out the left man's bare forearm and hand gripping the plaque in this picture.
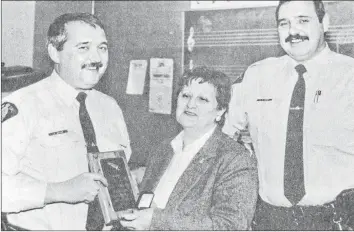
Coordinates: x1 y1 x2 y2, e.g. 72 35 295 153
44 173 108 204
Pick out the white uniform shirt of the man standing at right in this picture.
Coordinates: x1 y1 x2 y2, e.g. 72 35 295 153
223 46 354 206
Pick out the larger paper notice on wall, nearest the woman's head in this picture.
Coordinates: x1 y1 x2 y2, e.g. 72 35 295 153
149 58 173 114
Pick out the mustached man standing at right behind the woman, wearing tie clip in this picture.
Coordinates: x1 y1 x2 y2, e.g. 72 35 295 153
223 1 354 230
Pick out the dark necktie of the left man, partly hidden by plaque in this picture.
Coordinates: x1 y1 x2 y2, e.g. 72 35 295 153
76 92 104 230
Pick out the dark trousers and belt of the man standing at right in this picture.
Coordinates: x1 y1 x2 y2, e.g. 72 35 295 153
252 188 354 230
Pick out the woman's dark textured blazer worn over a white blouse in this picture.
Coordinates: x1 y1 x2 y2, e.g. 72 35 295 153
140 128 258 230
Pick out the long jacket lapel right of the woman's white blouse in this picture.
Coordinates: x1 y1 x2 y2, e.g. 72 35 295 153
166 127 222 207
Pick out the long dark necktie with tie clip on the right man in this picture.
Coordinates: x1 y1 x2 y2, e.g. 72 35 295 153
284 64 306 205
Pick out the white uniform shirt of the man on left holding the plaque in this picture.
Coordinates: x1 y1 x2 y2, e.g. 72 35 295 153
2 71 131 230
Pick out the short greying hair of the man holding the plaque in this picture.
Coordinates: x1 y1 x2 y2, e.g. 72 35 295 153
47 13 104 51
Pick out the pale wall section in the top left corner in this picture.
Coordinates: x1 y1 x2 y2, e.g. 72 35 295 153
1 1 36 67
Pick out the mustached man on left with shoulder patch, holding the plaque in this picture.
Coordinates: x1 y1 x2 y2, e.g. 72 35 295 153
2 13 131 230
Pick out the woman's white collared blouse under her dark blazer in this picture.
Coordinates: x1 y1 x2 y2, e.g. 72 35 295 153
154 126 216 209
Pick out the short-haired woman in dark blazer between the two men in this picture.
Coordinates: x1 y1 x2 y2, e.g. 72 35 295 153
120 67 258 230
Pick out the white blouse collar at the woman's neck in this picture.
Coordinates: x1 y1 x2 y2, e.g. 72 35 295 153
171 125 217 154
